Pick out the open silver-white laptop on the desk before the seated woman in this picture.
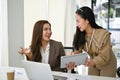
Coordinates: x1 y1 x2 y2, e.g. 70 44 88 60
22 60 67 80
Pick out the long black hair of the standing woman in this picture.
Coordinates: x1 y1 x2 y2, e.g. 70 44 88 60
73 6 102 50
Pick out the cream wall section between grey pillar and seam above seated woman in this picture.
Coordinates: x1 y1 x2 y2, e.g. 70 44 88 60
24 0 48 47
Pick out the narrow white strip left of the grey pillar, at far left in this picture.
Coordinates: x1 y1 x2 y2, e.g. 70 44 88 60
0 0 8 66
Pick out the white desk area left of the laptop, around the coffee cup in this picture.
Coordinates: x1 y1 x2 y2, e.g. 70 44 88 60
0 67 29 80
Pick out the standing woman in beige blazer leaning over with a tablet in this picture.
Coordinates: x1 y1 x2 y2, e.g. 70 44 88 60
67 6 117 77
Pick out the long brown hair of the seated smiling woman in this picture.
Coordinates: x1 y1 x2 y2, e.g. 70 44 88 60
30 20 51 62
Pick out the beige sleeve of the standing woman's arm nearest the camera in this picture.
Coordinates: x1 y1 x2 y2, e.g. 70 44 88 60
93 33 112 66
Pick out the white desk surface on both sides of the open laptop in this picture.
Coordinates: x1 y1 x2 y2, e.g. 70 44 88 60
0 67 120 80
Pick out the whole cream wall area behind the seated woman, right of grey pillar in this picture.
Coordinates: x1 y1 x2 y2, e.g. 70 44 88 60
24 0 66 47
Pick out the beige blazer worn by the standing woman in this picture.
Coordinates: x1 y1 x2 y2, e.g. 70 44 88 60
84 29 117 73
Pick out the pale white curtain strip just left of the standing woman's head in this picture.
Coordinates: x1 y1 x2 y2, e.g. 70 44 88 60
64 0 76 47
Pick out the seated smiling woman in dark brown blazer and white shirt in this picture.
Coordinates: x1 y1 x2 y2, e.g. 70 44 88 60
19 20 66 72
